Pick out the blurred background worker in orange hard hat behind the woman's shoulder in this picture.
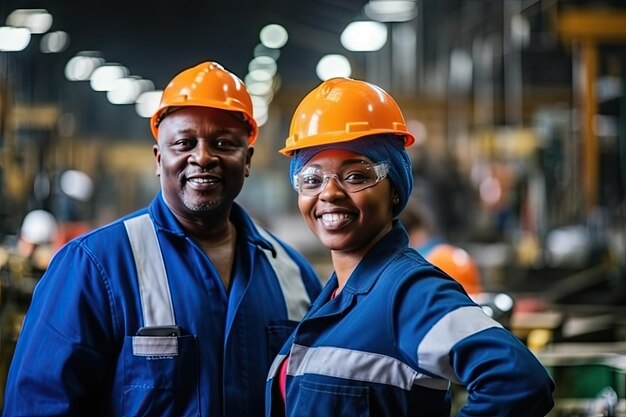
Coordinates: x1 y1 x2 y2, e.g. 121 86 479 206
399 196 483 296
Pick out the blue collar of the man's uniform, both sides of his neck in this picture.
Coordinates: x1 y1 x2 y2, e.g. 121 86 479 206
148 191 276 252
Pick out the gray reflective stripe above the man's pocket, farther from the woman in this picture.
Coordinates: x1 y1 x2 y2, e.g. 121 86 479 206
124 214 176 326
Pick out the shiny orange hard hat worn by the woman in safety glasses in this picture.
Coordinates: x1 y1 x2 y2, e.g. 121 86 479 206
280 78 415 156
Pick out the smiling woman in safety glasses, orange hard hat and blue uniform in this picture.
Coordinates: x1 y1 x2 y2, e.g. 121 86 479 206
266 78 554 417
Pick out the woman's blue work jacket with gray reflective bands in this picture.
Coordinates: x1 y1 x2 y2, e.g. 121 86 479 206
266 221 554 417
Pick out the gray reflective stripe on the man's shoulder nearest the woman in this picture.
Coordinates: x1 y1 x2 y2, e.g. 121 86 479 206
257 226 311 321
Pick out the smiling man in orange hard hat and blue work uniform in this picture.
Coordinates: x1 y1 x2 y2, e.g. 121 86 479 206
4 62 320 417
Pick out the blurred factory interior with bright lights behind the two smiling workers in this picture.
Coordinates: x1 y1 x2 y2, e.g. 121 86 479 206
0 0 626 417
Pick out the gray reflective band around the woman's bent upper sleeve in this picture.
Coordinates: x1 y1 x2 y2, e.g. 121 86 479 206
417 306 502 382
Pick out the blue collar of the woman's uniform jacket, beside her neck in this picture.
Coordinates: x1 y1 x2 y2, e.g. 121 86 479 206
333 220 409 294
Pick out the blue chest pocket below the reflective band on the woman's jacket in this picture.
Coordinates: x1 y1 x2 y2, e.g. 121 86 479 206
290 380 370 417
